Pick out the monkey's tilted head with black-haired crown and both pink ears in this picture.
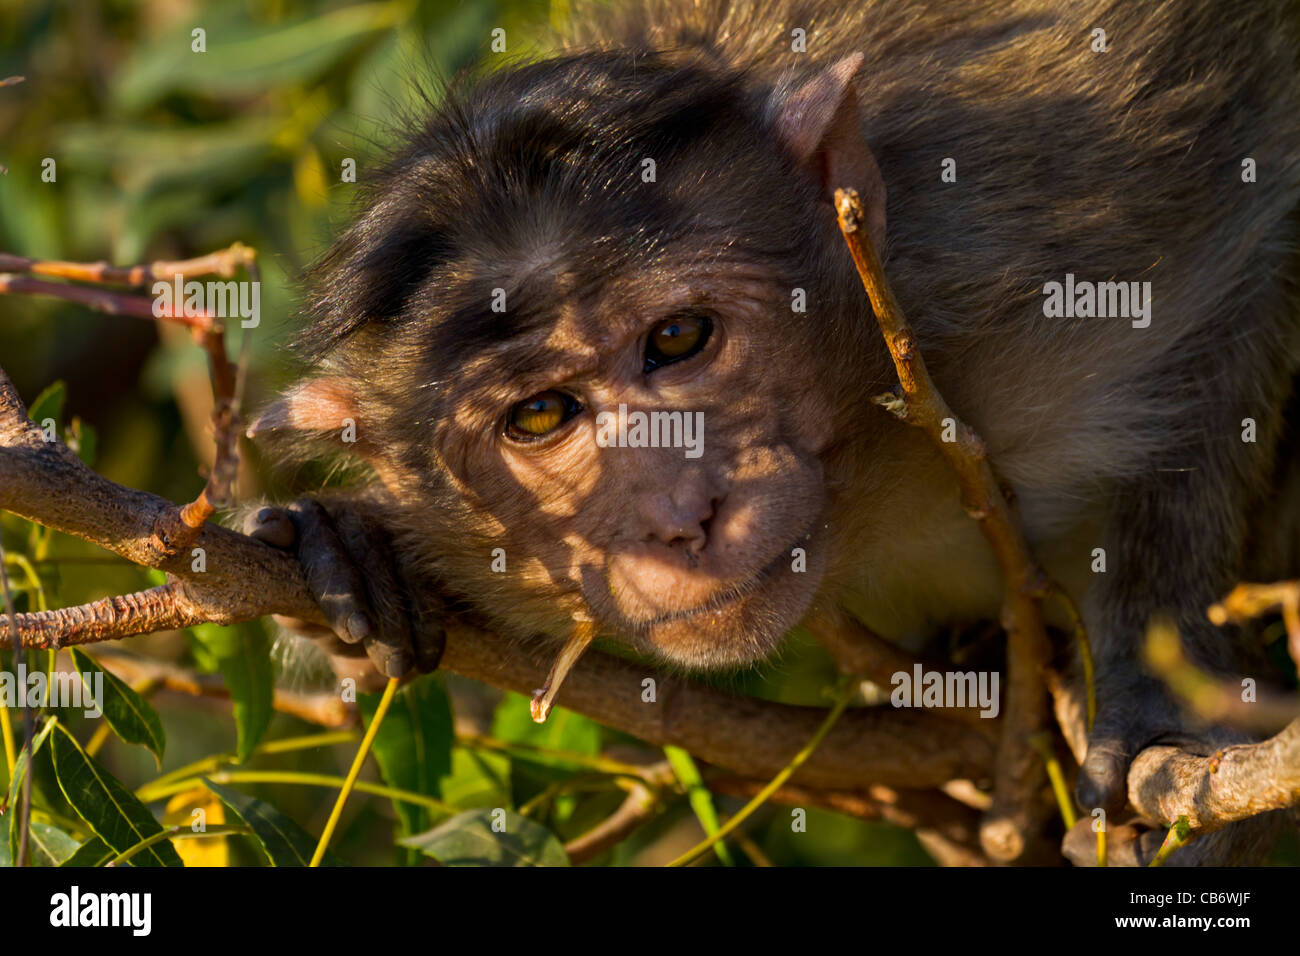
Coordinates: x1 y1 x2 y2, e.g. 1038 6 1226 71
268 46 884 667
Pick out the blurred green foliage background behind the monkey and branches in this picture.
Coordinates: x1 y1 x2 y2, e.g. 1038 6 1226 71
0 0 930 865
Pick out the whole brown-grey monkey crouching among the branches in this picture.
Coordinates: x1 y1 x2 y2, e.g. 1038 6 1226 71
251 0 1300 862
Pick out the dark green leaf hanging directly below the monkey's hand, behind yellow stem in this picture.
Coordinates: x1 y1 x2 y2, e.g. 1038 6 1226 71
356 674 452 835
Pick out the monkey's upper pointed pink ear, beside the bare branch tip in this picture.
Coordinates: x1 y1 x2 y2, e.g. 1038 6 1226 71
776 53 885 255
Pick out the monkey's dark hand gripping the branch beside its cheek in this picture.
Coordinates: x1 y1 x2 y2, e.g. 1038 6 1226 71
244 498 445 691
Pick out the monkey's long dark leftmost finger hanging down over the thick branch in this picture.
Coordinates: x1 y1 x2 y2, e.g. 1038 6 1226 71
289 498 376 644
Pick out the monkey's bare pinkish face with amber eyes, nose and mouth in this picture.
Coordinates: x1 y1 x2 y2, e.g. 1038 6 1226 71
405 255 831 666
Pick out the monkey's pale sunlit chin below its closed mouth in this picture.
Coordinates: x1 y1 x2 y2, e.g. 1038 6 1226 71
620 538 824 671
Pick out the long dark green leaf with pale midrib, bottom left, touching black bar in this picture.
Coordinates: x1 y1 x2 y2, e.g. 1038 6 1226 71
49 724 183 866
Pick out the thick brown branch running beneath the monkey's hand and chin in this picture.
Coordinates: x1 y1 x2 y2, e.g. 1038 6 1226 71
0 369 993 788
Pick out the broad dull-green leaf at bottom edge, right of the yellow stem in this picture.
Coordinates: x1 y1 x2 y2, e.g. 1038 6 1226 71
402 808 569 866
